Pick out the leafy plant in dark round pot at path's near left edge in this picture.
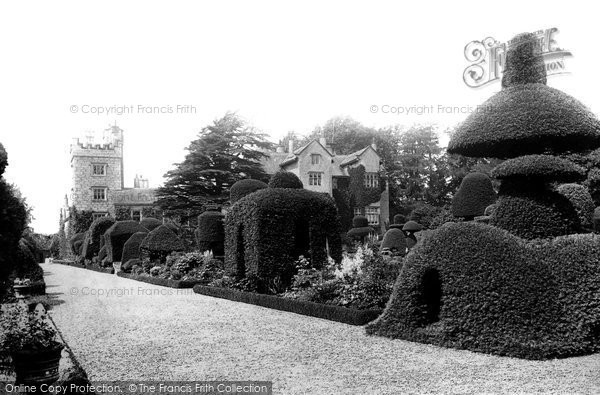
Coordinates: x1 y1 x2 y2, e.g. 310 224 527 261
0 303 64 385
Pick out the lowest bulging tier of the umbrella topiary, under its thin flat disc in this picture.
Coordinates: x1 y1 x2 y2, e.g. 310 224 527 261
490 180 580 239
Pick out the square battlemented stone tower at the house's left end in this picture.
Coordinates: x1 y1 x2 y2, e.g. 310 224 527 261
69 124 124 217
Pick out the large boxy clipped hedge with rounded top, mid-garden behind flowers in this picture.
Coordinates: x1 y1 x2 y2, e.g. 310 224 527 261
225 188 342 292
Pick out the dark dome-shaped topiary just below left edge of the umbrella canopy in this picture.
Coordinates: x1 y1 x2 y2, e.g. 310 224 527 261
452 173 496 219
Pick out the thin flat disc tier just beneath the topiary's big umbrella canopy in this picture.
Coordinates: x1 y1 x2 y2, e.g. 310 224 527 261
491 155 585 181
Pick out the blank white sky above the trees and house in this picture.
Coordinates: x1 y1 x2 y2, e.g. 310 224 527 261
0 0 600 233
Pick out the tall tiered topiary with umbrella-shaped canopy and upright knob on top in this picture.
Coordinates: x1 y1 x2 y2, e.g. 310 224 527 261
448 33 600 239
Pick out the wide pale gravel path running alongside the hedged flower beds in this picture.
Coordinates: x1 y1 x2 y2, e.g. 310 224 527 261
42 264 600 394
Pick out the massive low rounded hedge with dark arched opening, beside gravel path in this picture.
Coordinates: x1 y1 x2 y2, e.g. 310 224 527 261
366 222 600 359
